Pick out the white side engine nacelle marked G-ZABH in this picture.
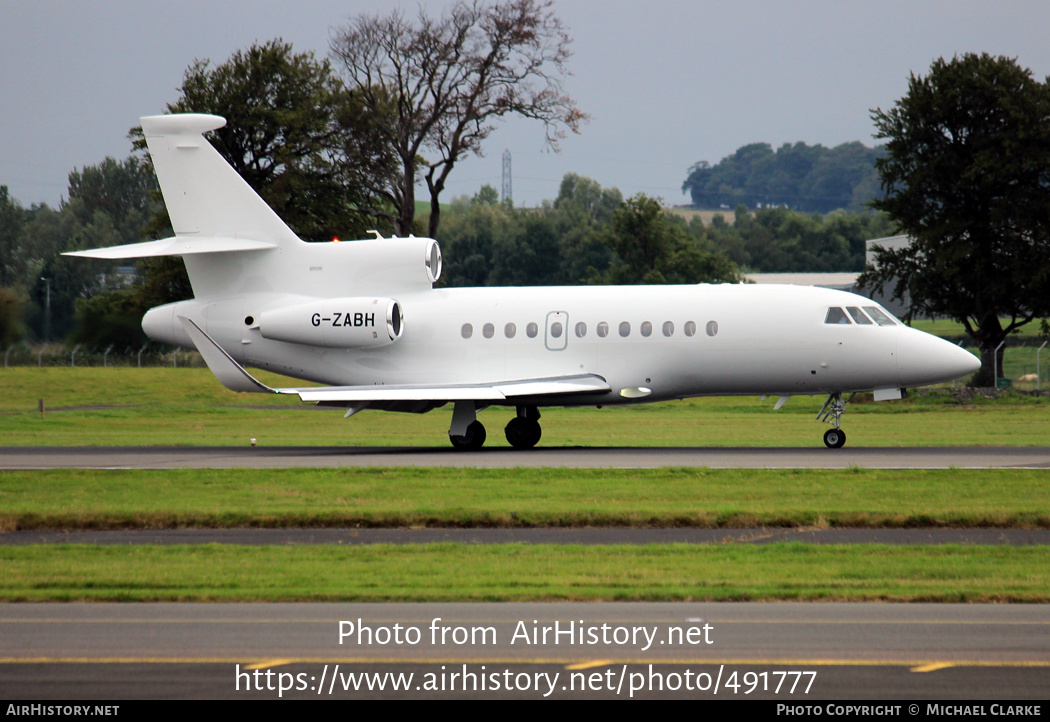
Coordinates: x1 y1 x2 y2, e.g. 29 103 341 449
256 298 404 348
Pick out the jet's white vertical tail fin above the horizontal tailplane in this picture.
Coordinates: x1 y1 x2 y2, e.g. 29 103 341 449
141 113 302 247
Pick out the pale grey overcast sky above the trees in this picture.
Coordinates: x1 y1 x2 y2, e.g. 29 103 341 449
0 0 1050 211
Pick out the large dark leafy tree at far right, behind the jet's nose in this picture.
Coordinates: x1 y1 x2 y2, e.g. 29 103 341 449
858 54 1050 385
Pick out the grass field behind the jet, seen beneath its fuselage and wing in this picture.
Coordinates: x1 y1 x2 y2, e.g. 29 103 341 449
0 369 1050 447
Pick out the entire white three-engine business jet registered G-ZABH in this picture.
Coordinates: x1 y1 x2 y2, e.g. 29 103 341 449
69 114 981 449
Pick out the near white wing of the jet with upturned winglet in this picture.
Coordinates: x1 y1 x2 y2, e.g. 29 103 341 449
179 316 611 403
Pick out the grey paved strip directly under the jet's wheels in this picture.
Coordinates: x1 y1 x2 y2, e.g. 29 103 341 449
6 445 1050 469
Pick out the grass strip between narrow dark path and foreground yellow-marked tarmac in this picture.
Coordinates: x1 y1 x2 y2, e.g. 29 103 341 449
0 544 1050 602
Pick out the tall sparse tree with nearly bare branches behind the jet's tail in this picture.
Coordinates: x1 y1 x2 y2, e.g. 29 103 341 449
332 0 586 236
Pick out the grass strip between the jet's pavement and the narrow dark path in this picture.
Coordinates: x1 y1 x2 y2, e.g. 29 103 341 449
0 468 1050 531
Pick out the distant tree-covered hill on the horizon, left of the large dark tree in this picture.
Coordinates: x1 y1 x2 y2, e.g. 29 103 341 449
681 142 883 213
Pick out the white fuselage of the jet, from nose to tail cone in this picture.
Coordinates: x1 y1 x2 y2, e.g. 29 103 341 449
144 284 973 405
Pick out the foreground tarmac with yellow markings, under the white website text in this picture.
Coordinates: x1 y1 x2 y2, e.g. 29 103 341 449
0 602 1050 701
